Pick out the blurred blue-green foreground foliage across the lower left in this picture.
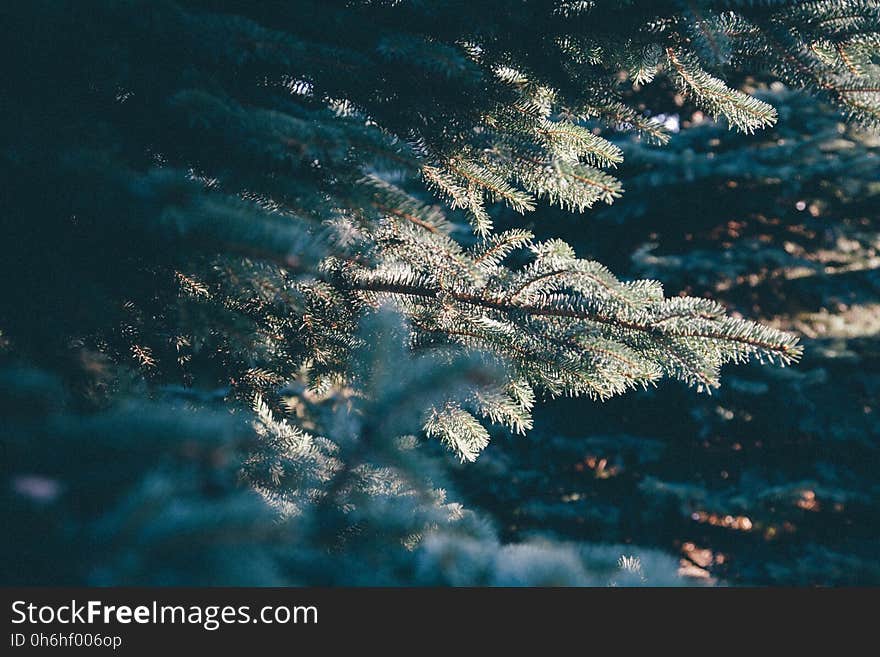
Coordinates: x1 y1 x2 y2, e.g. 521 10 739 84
0 313 680 586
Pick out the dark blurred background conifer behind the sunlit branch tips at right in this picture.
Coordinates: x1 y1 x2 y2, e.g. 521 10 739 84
456 87 880 586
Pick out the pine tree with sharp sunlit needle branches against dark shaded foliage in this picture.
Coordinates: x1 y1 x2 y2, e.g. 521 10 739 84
0 0 880 583
